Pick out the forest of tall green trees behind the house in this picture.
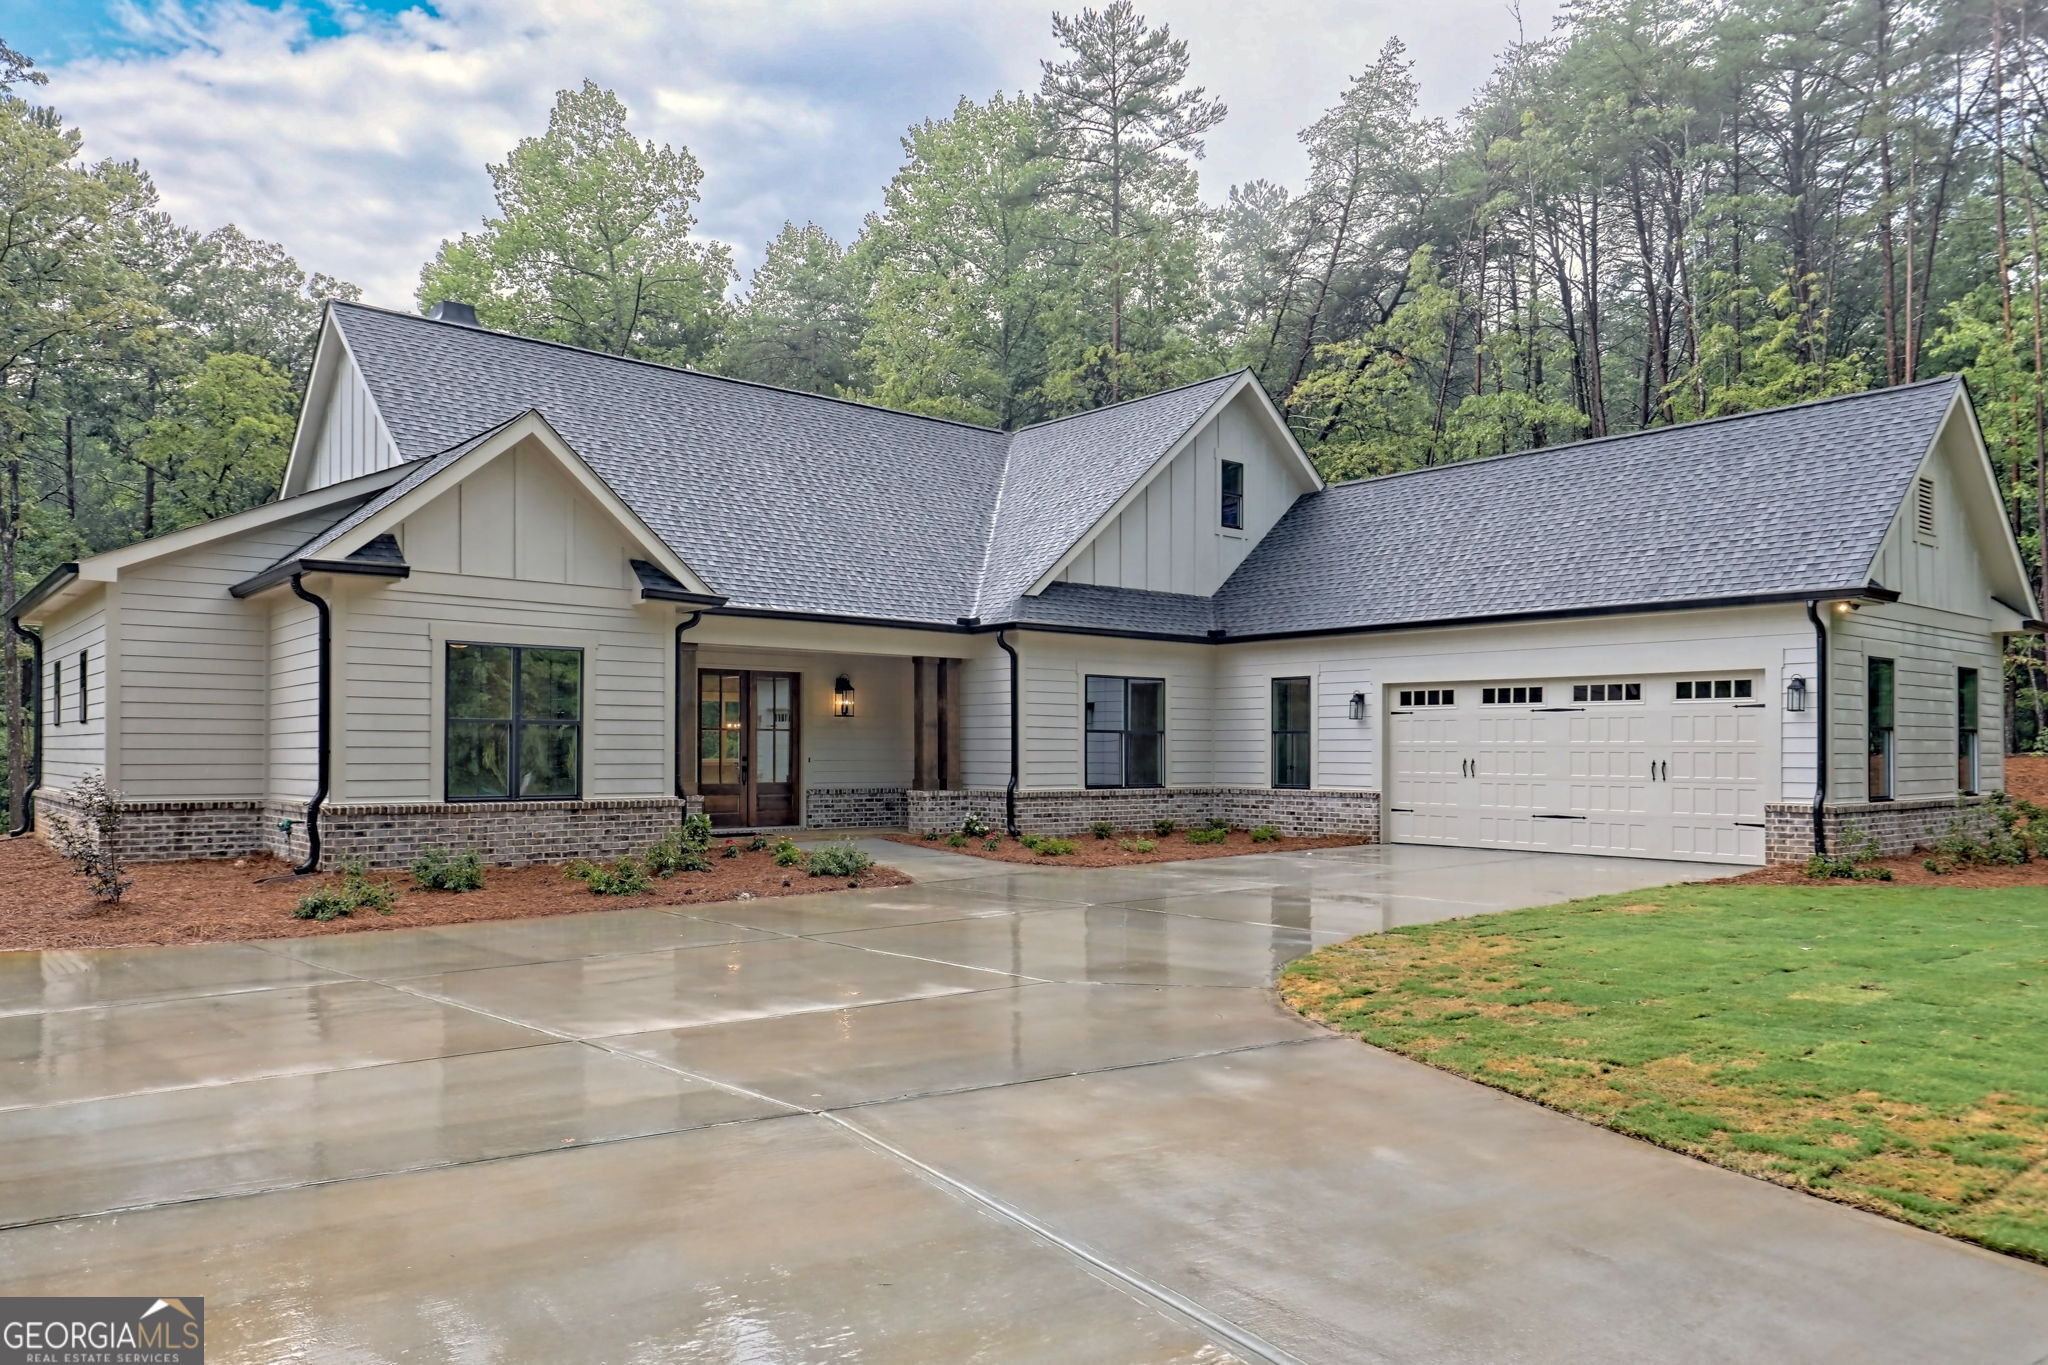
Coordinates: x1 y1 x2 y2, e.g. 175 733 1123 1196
0 0 2048 810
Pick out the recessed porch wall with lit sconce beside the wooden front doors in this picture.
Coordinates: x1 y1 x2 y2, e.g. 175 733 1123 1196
682 650 915 788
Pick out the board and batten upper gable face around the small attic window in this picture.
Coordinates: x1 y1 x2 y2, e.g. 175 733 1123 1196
1059 384 1311 596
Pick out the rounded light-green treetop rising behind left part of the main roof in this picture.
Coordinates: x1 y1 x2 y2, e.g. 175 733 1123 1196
418 80 733 364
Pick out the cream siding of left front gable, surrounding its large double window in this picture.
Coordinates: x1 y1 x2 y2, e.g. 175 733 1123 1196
334 442 676 804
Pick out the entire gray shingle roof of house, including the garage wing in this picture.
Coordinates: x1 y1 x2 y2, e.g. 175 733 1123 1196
319 305 1960 639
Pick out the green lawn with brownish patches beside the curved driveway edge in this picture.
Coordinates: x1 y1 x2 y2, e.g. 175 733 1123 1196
1280 886 2048 1261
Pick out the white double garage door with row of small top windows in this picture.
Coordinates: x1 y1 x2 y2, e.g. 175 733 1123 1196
1386 673 1767 862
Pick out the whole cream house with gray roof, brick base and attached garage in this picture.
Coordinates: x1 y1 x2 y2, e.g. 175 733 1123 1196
12 305 2042 866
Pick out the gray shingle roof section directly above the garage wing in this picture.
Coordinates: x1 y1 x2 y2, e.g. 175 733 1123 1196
1217 377 1962 636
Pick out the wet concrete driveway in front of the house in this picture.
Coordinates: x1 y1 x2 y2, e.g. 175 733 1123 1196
0 845 2048 1365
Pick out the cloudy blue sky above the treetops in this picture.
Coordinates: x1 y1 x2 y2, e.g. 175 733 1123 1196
0 0 1556 307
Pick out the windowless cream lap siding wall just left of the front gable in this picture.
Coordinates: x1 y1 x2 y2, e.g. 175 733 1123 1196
115 510 350 800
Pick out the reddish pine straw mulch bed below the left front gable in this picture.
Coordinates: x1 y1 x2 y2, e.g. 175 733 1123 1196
0 837 909 950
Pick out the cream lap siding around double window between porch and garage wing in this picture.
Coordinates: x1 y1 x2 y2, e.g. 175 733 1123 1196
1004 632 1214 790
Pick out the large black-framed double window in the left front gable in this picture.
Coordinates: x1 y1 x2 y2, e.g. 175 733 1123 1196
446 645 584 800
